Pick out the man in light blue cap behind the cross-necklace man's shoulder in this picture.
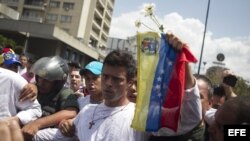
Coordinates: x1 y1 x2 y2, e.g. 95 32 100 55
55 61 103 141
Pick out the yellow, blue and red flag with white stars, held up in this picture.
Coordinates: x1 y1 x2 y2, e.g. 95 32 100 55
131 32 196 131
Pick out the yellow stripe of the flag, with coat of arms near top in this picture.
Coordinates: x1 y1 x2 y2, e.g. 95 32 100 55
131 32 159 131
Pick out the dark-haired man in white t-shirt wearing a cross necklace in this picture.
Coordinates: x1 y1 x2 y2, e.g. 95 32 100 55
74 51 146 141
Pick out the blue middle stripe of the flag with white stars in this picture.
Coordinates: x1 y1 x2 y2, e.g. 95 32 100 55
146 34 177 131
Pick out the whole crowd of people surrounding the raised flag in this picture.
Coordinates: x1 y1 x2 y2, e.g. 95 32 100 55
0 34 250 141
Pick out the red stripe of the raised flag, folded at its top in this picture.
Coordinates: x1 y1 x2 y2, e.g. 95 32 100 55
161 47 197 132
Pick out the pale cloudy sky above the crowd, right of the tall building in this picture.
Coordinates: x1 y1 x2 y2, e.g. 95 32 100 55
109 0 250 80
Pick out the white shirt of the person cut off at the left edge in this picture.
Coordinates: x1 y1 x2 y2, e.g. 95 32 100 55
0 67 42 125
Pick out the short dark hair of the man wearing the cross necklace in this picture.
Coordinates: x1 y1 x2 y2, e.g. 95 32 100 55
103 50 136 80
